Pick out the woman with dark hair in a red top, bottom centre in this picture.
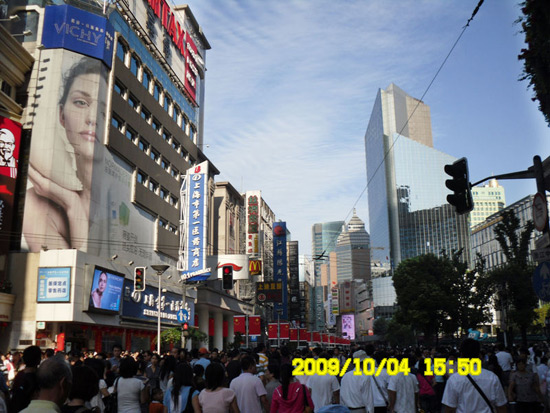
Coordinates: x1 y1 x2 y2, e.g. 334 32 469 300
271 364 315 413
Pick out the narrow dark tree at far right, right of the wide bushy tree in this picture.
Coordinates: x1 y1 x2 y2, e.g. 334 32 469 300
490 210 538 345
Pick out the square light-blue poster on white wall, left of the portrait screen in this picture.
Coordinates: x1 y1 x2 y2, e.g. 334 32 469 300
36 267 71 303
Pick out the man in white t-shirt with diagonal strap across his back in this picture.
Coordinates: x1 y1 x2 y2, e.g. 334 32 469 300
442 338 507 413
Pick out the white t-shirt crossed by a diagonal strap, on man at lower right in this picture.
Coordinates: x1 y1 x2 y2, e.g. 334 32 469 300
441 369 507 413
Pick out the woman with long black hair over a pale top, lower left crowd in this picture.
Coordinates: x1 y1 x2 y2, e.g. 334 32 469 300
163 363 199 413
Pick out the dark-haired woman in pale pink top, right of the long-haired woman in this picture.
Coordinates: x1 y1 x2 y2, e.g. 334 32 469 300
193 363 240 413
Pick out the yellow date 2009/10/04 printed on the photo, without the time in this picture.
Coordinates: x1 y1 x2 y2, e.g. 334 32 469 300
292 358 411 377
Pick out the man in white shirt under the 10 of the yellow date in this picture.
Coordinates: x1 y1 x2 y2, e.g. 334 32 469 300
340 350 374 413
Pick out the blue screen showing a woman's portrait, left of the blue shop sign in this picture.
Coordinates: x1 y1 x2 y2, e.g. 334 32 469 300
88 267 124 312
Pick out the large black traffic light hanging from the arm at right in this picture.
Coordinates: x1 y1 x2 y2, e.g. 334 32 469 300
445 158 474 214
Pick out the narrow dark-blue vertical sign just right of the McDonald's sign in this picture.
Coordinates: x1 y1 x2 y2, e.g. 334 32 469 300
273 222 288 320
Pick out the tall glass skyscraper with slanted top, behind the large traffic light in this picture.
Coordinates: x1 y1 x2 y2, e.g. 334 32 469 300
365 84 471 274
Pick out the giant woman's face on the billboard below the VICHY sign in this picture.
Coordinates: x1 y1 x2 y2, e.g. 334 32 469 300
59 73 105 159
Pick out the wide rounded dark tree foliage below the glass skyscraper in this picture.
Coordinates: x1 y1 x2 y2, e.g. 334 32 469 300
393 251 492 338
